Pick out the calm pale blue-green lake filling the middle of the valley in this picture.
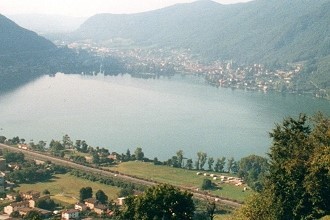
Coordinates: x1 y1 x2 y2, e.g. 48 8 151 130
0 74 330 160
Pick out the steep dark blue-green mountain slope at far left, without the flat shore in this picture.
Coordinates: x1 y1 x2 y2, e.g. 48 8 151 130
0 15 57 91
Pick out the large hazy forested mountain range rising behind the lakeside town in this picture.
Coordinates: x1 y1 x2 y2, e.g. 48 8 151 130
71 0 330 93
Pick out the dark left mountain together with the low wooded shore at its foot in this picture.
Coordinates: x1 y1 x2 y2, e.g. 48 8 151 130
0 15 121 91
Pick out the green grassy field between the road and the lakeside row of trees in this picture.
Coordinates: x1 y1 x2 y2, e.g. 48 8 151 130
110 161 251 201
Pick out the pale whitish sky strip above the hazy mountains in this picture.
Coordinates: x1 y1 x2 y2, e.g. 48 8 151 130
0 0 253 17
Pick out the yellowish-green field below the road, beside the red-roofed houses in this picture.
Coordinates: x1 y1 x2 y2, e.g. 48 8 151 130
16 174 120 204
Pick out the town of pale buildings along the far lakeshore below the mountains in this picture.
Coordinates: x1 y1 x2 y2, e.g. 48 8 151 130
61 42 328 98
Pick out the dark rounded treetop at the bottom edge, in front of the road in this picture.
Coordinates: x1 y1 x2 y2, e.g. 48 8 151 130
121 184 195 220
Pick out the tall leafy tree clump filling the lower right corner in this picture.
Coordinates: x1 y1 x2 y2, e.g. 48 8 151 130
237 114 330 219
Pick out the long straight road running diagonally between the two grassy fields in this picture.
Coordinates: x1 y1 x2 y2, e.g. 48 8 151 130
0 144 241 208
